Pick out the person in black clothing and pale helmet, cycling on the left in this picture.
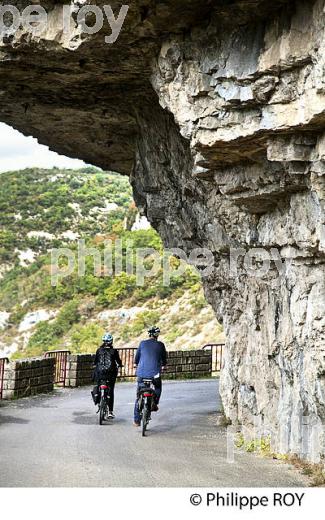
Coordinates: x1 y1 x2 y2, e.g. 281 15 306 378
92 334 123 419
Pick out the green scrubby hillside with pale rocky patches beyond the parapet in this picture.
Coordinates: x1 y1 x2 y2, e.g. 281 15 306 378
0 168 221 357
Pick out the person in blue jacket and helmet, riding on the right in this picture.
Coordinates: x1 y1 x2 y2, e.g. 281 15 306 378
134 327 167 426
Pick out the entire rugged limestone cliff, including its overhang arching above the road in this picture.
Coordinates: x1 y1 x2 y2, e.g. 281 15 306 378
0 0 325 459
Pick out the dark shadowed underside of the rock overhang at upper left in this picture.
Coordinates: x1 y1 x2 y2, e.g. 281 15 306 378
0 0 298 174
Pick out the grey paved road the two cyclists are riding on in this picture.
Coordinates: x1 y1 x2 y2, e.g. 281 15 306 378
0 380 306 487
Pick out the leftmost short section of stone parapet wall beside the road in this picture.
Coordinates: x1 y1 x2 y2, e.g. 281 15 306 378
3 358 55 399
